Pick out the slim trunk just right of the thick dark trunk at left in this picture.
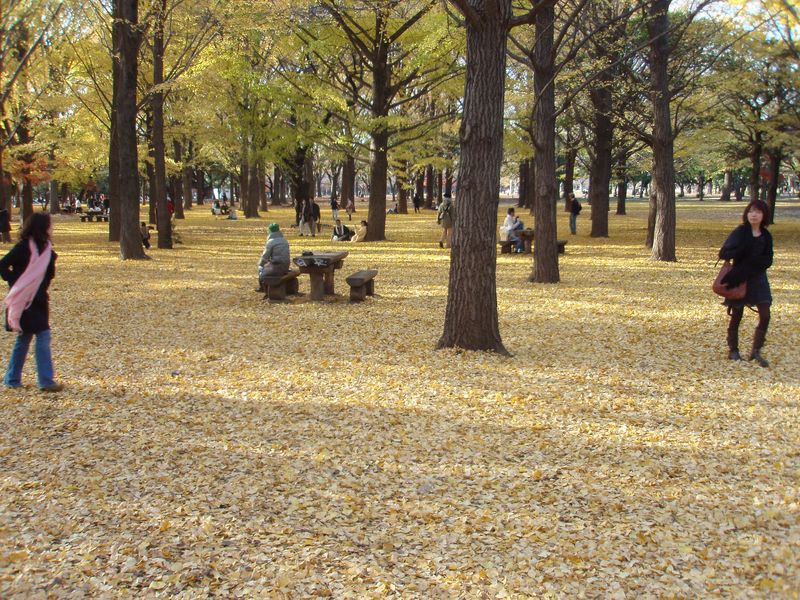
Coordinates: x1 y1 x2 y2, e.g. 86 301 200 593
150 0 175 249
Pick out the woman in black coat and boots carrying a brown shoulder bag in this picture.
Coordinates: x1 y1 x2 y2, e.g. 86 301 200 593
719 200 772 367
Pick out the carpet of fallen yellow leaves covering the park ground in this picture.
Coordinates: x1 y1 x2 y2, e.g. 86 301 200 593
0 203 800 598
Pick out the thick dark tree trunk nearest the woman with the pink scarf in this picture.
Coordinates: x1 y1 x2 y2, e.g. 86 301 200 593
115 0 146 260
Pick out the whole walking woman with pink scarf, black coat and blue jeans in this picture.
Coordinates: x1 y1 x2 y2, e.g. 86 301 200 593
0 212 64 392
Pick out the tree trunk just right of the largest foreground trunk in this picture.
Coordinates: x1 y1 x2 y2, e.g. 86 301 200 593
530 4 560 283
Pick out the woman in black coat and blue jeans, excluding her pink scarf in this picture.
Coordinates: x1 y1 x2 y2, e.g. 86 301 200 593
0 213 64 392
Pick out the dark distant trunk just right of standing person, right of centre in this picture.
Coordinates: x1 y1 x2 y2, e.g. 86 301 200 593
589 85 614 237
